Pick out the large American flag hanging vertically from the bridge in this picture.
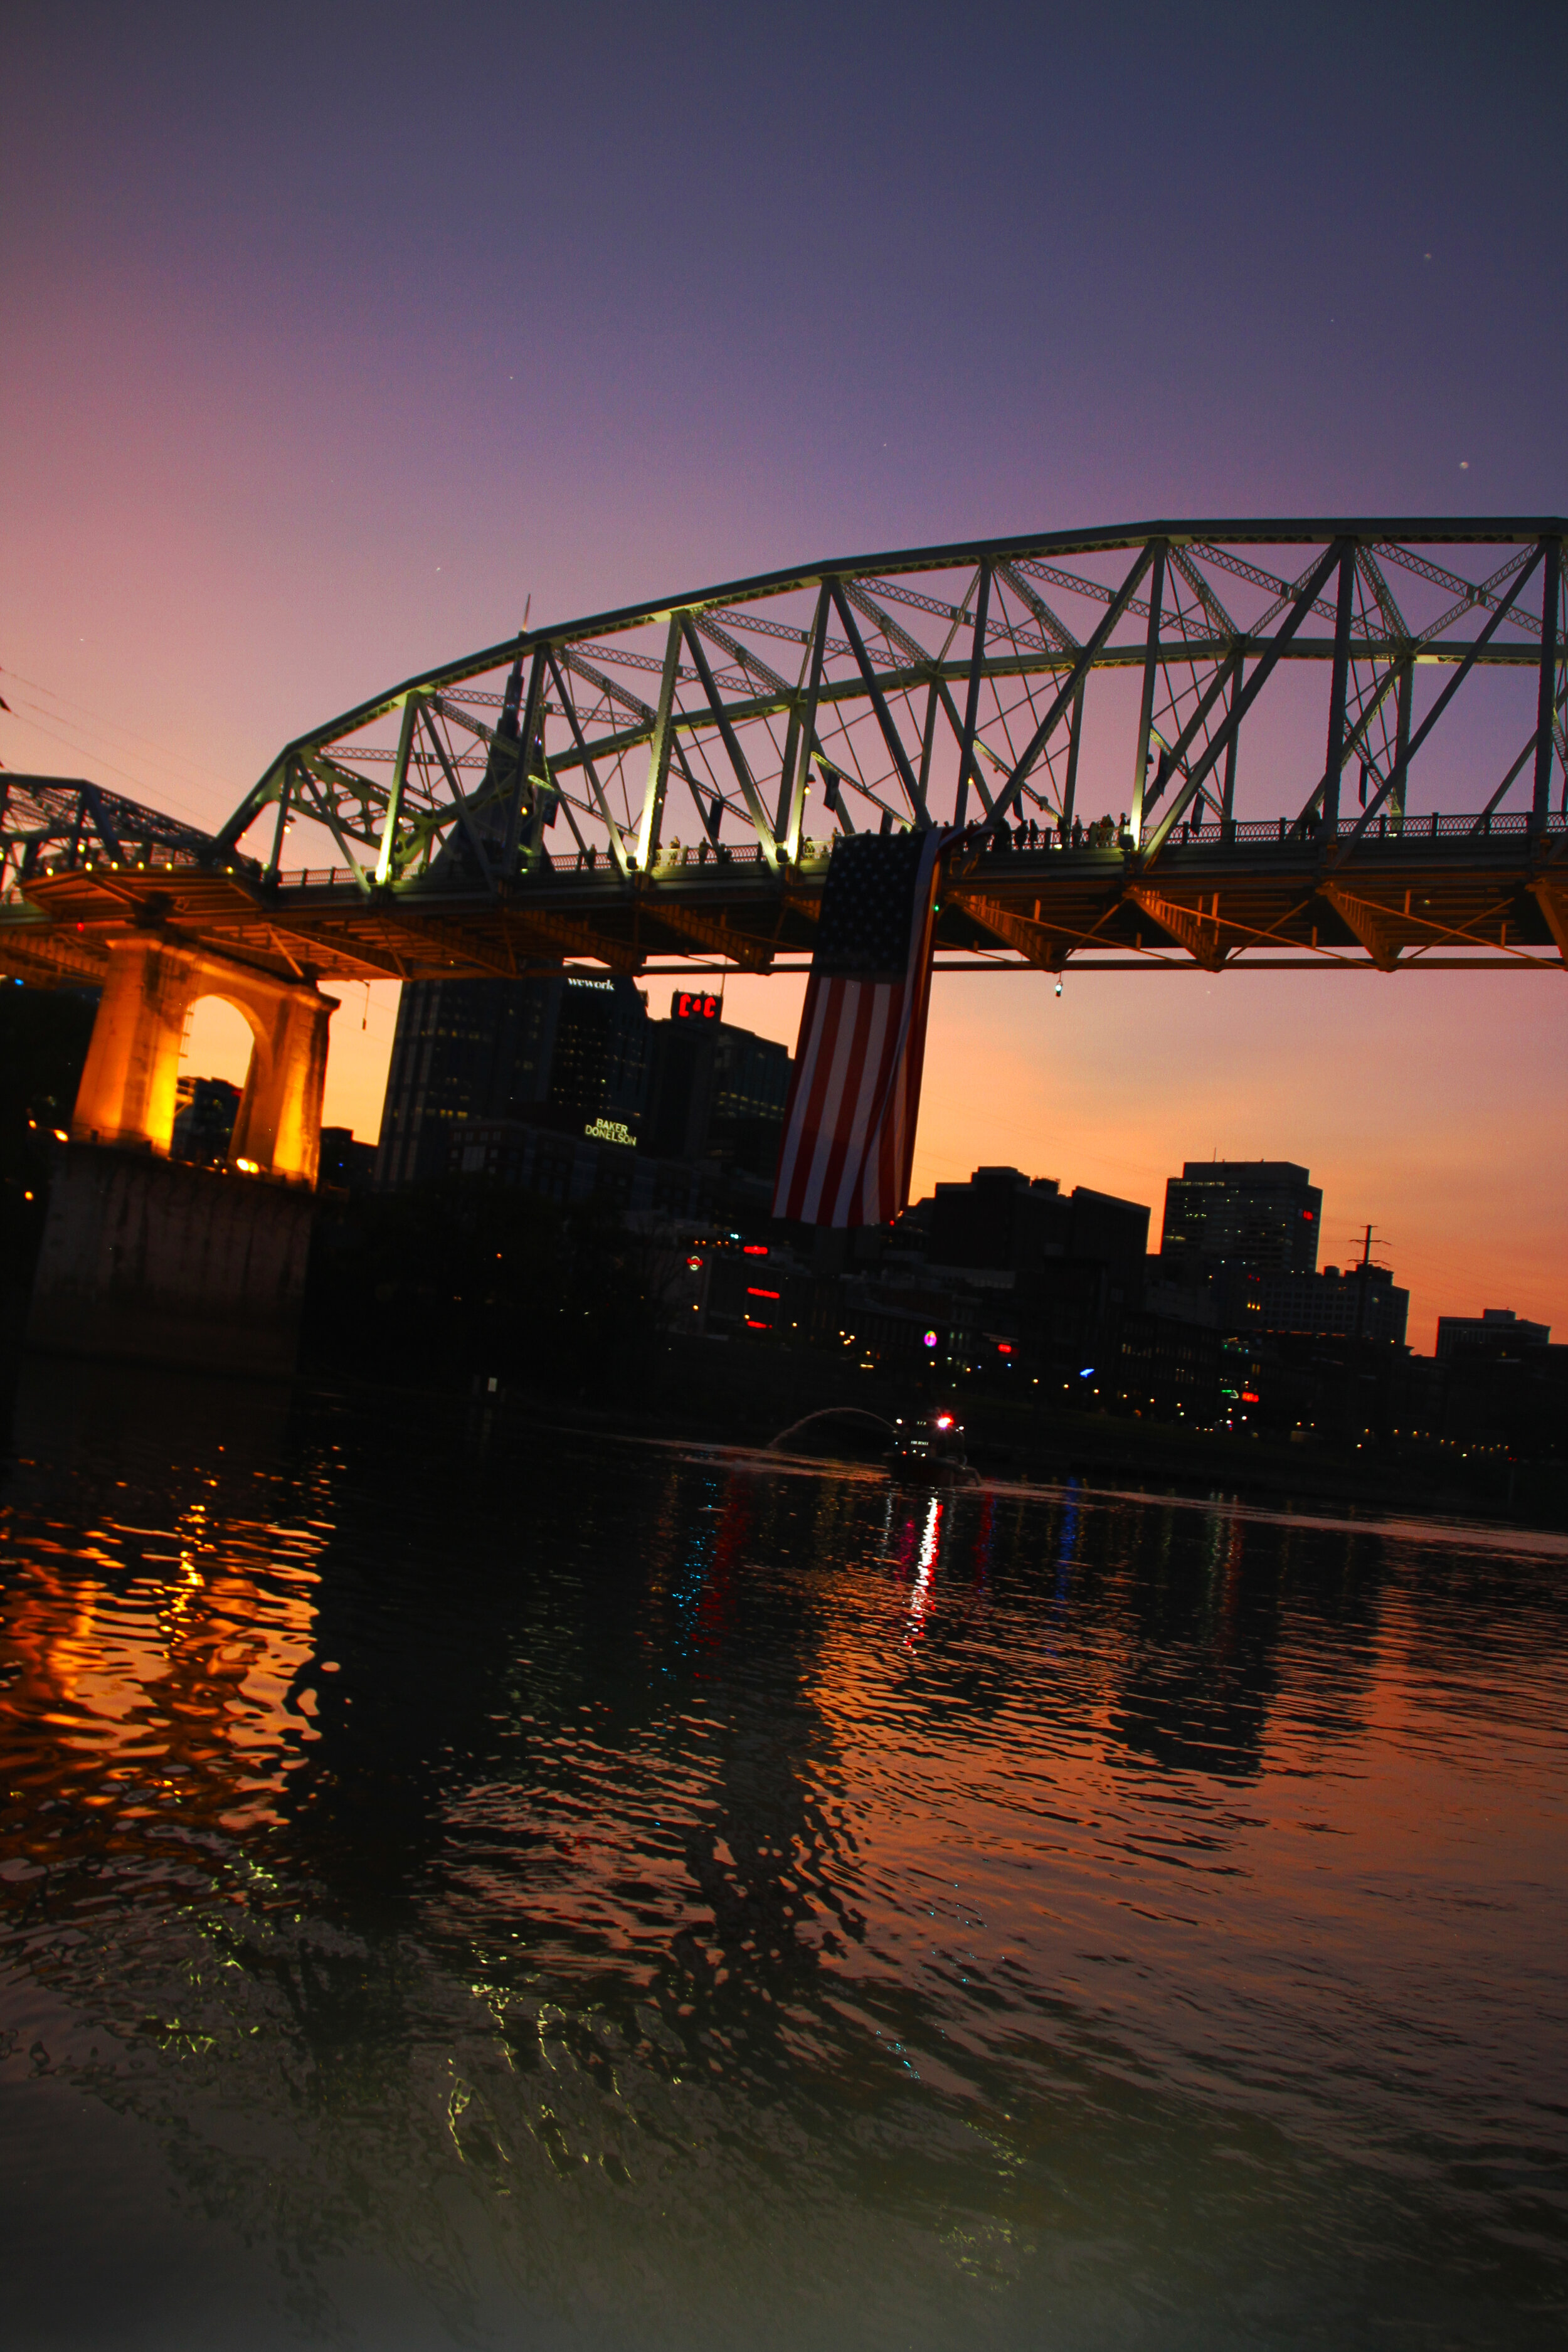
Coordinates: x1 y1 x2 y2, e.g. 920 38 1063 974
773 833 943 1226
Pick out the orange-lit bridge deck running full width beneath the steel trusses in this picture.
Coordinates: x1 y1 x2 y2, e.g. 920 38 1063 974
0 816 1568 981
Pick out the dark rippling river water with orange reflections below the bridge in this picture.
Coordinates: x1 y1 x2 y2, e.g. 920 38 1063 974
0 1371 1568 2352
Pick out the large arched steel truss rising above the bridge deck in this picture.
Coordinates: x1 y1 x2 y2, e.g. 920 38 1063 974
186 517 1568 889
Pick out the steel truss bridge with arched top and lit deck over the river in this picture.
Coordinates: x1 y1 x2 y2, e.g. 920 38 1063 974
0 517 1568 981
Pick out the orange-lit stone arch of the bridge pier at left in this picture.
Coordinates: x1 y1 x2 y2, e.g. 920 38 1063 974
70 931 336 1185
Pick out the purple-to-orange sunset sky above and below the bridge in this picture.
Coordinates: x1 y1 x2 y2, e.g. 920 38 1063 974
0 0 1568 1350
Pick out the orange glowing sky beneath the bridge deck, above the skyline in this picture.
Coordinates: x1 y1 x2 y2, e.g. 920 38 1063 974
181 945 1568 1355
